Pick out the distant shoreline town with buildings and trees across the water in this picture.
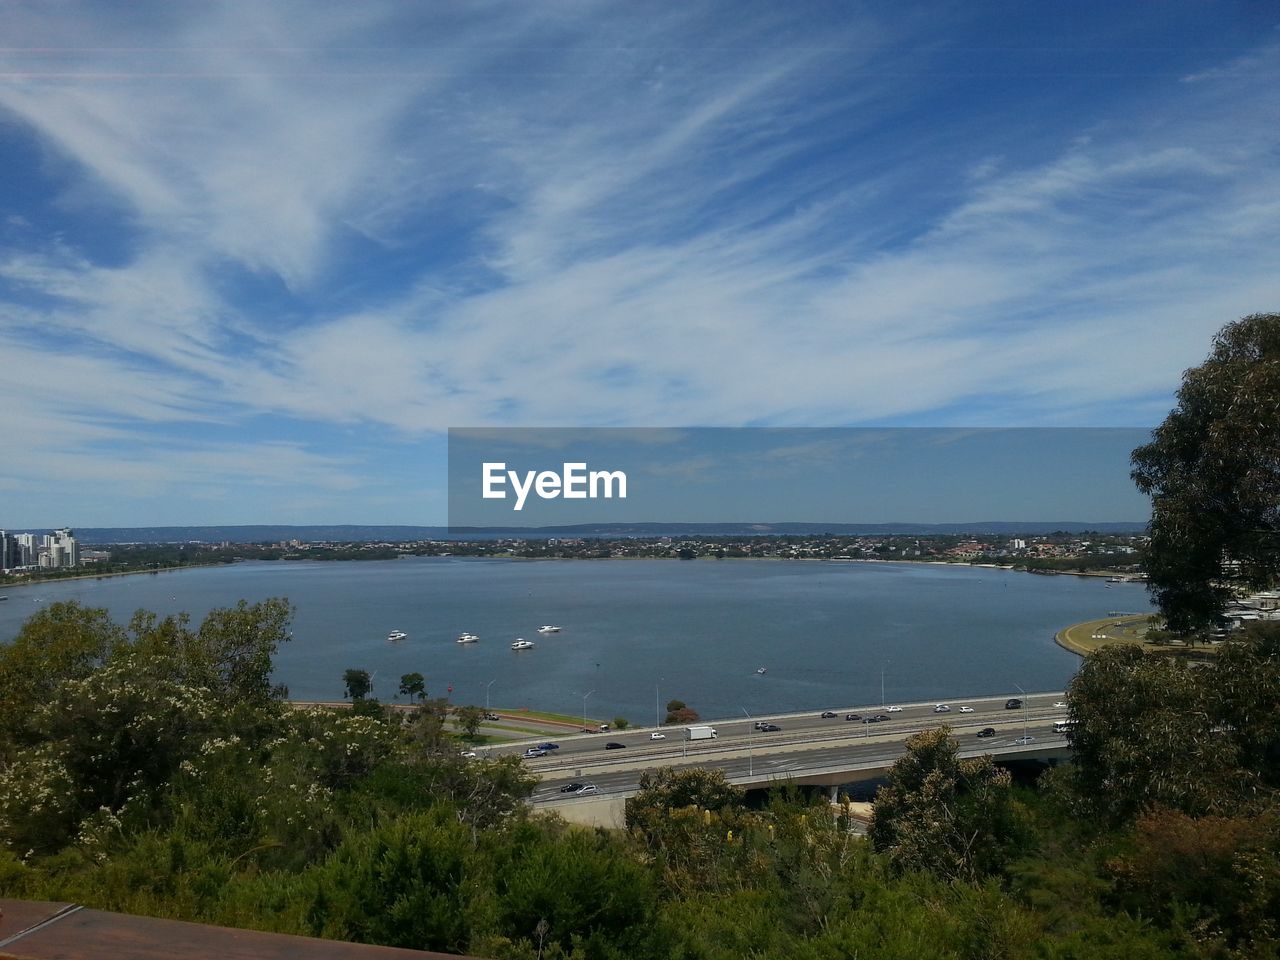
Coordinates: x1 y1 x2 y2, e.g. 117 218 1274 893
0 529 1147 582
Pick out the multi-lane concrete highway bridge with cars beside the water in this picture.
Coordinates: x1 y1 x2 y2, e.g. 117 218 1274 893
490 691 1069 826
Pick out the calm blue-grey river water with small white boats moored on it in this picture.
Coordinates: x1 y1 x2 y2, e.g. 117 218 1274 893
0 558 1149 722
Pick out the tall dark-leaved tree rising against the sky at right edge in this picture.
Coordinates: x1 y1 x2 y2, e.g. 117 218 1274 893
1132 314 1280 632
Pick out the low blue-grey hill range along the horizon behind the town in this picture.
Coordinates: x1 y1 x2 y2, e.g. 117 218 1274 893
67 520 1147 544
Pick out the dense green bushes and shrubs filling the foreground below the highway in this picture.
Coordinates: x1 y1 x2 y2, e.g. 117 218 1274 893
0 600 1280 960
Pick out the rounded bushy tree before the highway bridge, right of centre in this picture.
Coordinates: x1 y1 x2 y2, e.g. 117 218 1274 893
868 727 1014 879
